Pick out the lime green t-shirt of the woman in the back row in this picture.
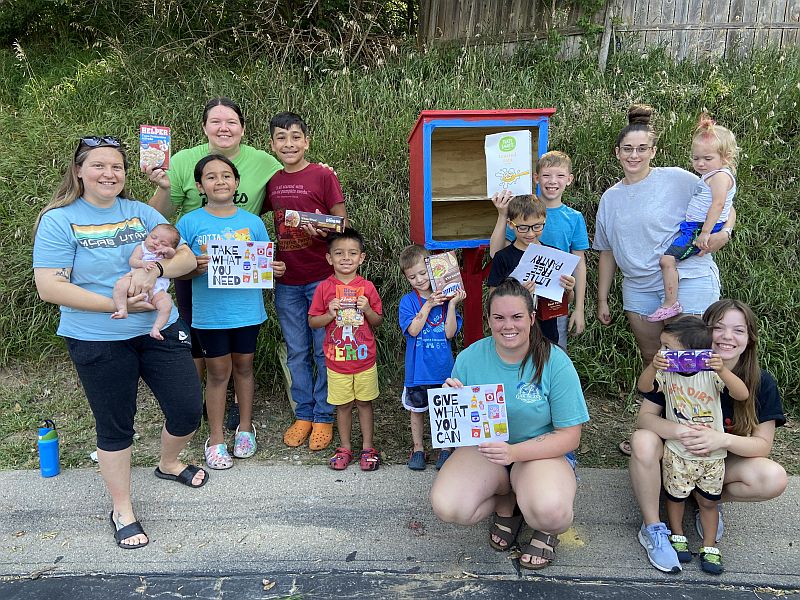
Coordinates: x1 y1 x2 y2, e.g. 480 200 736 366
167 144 283 216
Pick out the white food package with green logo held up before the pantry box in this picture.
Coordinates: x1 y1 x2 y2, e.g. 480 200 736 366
484 129 533 198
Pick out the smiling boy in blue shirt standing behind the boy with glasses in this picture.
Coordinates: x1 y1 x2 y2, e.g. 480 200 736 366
489 150 589 350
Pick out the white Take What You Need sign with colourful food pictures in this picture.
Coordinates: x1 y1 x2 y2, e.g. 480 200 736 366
206 240 274 290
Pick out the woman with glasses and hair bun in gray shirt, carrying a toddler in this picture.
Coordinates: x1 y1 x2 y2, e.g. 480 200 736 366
593 104 736 365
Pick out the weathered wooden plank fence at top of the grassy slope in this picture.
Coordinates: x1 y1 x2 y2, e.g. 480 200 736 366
418 0 800 60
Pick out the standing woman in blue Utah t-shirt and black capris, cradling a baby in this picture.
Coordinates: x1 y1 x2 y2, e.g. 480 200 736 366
33 137 208 549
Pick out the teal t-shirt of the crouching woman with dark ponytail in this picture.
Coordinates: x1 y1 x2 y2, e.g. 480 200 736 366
452 337 589 444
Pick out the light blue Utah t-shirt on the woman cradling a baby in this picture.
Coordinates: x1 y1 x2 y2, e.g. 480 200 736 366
33 198 183 342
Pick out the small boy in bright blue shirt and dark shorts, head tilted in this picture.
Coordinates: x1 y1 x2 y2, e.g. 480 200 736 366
399 245 467 471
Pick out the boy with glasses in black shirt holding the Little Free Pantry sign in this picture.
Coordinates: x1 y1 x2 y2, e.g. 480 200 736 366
486 195 575 344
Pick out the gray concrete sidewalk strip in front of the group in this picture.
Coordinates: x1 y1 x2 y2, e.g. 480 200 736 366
0 463 800 589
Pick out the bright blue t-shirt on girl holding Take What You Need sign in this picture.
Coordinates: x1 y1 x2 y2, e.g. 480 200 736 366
177 208 269 329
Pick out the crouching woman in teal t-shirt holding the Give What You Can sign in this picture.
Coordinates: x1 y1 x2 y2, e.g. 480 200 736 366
431 279 589 569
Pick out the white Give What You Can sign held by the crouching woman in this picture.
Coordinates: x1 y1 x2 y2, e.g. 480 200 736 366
428 383 508 448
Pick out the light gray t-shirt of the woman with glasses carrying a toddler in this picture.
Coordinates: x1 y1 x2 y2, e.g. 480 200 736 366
592 167 719 291
